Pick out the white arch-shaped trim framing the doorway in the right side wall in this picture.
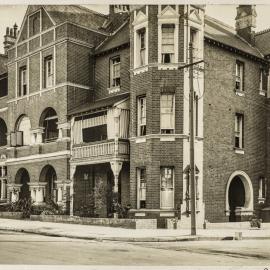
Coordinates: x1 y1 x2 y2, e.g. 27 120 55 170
225 171 254 215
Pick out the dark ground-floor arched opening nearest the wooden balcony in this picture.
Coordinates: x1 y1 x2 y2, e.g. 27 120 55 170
39 165 57 202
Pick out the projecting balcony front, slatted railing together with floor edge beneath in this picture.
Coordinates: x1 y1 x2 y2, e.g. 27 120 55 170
72 139 129 165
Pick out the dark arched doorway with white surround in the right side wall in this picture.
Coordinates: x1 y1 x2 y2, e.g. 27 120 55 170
226 171 253 222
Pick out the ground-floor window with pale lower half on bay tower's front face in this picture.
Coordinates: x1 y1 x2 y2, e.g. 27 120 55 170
160 167 174 209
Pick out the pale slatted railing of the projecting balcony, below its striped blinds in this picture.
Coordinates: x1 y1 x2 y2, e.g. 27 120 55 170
72 140 129 159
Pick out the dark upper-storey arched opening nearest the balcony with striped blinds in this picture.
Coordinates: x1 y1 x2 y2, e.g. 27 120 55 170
41 108 58 142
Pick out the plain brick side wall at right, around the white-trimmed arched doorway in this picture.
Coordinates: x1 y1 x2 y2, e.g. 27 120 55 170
204 43 267 222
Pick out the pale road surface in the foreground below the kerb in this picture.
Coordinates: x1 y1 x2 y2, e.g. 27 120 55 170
0 231 270 269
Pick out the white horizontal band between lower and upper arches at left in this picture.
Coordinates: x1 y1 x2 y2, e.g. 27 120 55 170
6 150 70 164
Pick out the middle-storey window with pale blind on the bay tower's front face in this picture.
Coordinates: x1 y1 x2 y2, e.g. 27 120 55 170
160 94 175 134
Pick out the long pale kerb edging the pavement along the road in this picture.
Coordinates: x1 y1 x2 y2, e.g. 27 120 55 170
0 227 270 242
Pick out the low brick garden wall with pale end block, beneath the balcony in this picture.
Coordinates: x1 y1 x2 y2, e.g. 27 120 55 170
30 215 157 229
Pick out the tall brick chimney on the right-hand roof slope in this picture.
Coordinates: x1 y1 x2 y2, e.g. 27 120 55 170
235 5 257 46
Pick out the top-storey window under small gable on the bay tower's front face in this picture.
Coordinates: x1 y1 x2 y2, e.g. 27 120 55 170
161 24 175 64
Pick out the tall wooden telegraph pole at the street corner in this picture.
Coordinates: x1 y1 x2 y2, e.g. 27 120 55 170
189 42 196 235
